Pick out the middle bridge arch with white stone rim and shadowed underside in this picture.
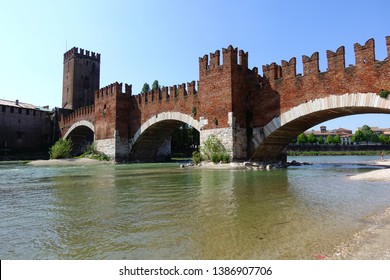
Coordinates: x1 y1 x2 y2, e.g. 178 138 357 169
129 112 200 161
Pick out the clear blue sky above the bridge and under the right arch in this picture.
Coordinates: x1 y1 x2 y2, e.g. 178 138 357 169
0 0 390 130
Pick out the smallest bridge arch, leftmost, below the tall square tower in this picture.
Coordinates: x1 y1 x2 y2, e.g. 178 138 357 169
63 120 95 154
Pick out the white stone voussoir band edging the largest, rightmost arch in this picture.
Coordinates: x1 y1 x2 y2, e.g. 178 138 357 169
257 92 390 142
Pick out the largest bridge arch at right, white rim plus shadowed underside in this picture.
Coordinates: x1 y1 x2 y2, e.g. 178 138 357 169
251 92 390 161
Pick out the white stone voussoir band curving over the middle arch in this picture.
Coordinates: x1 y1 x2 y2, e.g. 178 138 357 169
131 112 200 144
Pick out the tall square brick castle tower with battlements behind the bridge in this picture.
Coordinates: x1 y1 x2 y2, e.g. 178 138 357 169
62 47 100 110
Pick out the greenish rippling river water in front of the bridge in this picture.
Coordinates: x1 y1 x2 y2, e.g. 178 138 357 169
0 156 390 260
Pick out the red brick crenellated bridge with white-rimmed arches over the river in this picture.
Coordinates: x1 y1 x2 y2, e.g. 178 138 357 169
60 36 390 162
